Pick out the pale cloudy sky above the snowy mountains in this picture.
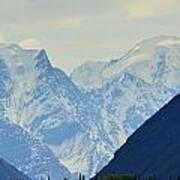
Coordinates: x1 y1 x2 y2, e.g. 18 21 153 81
0 0 180 74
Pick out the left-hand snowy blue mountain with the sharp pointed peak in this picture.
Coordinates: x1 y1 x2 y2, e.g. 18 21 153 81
0 45 100 177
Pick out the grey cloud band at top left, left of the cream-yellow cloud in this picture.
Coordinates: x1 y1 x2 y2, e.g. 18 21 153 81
0 0 114 26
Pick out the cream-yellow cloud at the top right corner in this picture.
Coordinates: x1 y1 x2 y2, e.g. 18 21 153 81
125 0 179 19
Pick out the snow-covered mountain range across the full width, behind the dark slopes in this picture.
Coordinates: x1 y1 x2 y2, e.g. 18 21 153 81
0 36 180 180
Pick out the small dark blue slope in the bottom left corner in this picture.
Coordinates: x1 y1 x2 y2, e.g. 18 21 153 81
0 159 30 180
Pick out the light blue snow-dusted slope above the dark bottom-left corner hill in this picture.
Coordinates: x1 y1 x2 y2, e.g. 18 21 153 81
0 119 70 180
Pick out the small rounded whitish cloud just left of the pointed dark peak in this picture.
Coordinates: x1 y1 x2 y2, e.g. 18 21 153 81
19 39 41 49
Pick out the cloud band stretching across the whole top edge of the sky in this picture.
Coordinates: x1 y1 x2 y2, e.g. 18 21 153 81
0 0 180 24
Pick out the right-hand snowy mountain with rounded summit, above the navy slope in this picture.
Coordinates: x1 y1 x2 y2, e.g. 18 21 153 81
71 36 180 176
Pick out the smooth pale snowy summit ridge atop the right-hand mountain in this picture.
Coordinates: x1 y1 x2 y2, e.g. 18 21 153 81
71 35 180 90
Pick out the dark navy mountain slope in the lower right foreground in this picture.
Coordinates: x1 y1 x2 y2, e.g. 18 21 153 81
95 95 180 180
